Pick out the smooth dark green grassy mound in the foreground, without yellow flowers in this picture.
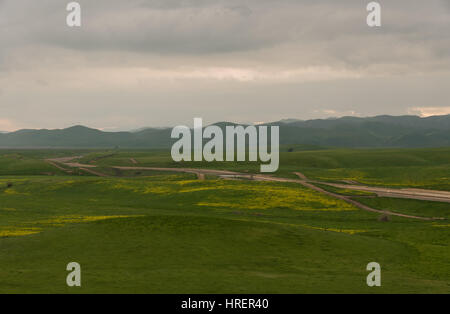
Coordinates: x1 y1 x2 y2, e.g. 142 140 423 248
0 215 442 293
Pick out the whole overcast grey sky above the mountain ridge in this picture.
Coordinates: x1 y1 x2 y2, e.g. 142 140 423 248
0 0 450 131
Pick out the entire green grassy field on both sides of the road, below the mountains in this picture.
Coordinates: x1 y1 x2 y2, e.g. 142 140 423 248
0 149 450 293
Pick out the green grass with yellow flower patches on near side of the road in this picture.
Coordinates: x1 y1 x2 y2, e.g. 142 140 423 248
0 175 450 293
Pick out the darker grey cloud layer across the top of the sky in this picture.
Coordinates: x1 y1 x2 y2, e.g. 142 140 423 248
0 0 450 67
